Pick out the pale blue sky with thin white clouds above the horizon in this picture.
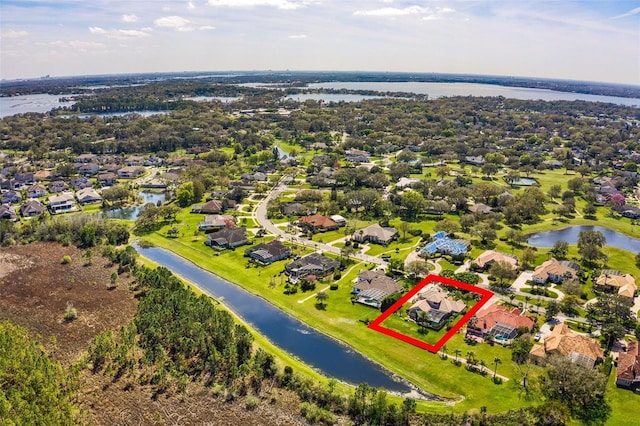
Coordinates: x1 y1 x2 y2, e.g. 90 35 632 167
0 0 640 85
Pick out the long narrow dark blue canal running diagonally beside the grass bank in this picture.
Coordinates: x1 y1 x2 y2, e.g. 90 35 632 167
135 245 428 399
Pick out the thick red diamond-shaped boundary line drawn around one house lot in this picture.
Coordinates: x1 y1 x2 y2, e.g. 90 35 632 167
368 275 493 353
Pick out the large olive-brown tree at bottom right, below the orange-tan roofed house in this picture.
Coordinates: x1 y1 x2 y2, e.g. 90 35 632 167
540 356 611 424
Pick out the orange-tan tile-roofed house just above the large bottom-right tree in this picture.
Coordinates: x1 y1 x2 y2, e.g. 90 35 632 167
529 324 604 368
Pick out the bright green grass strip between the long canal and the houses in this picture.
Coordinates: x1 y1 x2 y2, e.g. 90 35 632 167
145 233 534 412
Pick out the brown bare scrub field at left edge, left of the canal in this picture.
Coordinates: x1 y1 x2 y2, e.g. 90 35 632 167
0 243 137 363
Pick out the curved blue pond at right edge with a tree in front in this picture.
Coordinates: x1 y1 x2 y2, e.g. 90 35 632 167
527 226 640 253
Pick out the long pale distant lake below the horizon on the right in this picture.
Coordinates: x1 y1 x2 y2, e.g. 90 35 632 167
308 81 640 107
